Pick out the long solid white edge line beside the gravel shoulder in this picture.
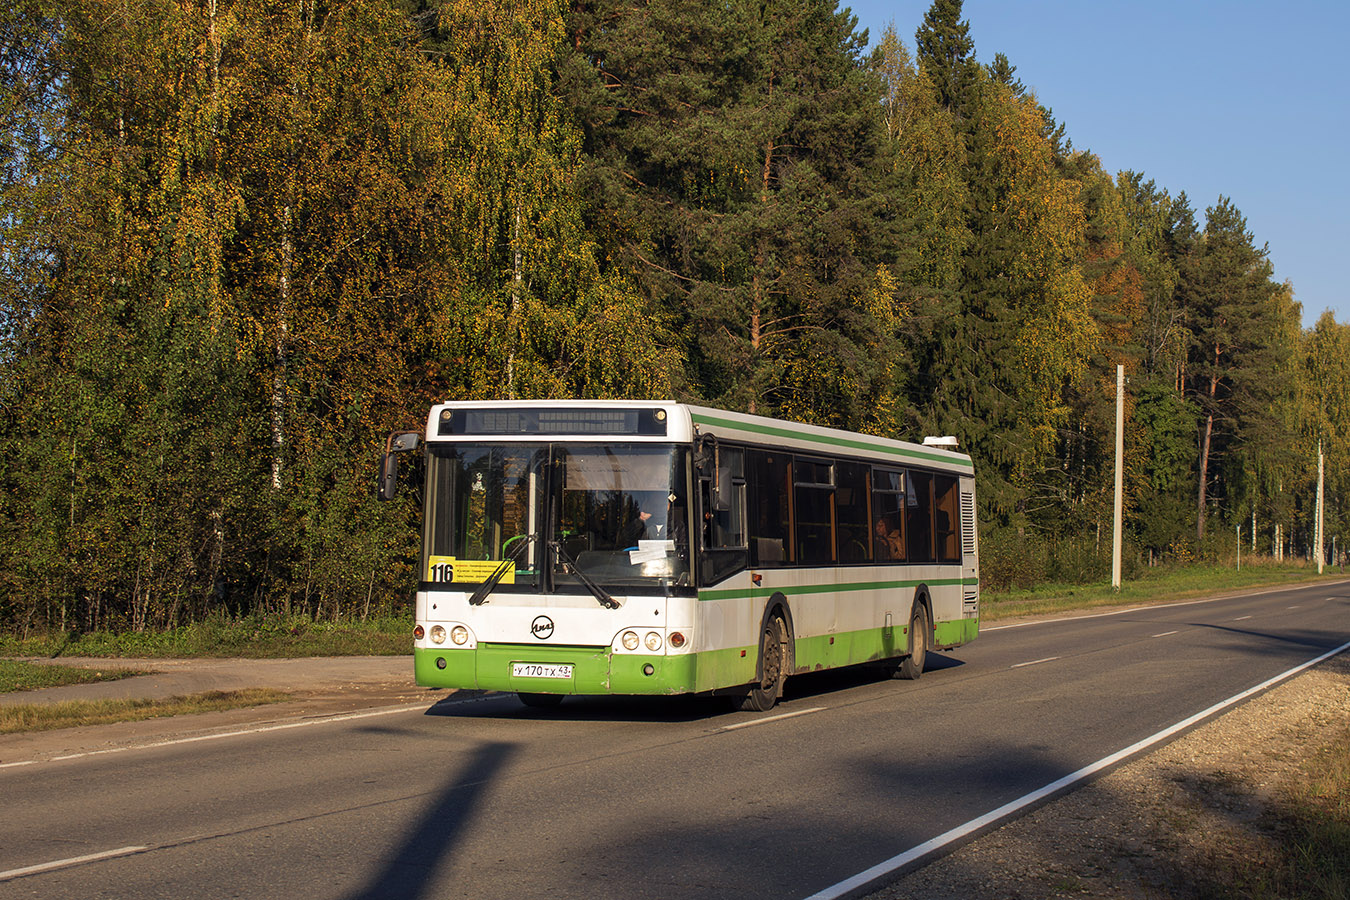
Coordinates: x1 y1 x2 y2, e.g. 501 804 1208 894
806 642 1350 900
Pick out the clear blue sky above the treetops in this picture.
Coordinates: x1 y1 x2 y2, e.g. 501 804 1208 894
841 0 1350 327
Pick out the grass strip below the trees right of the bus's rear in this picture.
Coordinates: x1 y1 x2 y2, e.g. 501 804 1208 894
980 561 1346 621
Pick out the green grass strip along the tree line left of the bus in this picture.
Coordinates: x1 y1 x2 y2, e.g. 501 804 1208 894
0 617 413 658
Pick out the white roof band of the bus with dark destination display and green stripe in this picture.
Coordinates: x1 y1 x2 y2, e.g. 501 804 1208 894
427 399 973 475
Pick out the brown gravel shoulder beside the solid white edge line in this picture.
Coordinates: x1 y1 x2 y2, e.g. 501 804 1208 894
868 653 1350 900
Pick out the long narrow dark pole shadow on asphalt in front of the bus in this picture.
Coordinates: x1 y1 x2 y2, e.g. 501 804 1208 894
347 742 514 900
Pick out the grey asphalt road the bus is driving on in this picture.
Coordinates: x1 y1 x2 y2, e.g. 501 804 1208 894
0 583 1350 900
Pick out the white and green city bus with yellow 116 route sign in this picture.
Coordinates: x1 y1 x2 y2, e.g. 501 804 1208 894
379 401 980 711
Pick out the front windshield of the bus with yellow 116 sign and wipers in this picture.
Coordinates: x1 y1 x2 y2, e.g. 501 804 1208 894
423 443 690 591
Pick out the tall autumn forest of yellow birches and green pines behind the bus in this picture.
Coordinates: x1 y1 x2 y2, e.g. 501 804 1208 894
0 0 1350 630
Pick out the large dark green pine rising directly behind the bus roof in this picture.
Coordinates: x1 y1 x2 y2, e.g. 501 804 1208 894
568 0 898 425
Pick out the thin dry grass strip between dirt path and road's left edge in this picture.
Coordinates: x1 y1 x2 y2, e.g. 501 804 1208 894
0 688 290 734
